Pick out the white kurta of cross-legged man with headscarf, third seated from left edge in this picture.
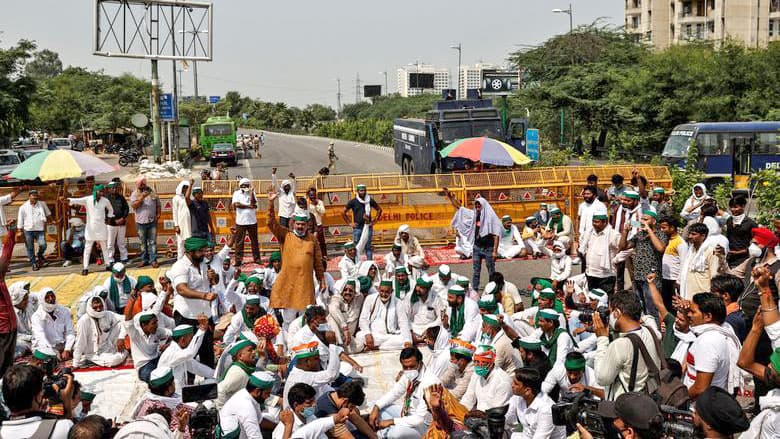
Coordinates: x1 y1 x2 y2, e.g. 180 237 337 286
73 311 127 367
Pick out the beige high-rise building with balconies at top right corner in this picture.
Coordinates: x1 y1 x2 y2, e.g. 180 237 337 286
625 0 780 49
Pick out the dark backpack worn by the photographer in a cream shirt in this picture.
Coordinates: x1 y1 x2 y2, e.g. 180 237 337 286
626 330 690 409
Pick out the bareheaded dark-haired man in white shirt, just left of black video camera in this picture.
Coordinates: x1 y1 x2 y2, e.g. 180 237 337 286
505 367 566 439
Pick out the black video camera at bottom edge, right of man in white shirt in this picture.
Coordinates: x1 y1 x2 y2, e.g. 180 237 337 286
552 390 609 438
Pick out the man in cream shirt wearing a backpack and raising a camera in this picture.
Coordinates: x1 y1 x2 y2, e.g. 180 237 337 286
593 291 661 401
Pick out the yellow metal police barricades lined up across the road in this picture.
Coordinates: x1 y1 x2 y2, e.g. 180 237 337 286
0 165 672 262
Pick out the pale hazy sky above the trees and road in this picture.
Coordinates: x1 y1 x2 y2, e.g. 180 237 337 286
0 0 624 107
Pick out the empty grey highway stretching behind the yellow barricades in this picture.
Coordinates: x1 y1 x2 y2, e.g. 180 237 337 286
229 129 400 179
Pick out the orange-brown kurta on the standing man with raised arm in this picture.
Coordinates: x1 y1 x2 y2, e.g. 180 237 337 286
268 215 323 311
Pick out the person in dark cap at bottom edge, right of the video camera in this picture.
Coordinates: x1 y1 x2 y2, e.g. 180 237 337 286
577 392 664 439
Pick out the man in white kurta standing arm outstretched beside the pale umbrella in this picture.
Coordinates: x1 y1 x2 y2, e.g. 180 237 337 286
68 184 114 276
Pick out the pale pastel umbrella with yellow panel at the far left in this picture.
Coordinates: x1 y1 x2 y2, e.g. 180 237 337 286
10 149 117 181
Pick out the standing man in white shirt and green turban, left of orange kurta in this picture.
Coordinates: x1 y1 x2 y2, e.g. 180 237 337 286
170 236 218 368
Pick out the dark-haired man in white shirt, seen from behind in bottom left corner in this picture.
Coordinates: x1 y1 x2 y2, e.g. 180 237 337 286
0 364 73 439
